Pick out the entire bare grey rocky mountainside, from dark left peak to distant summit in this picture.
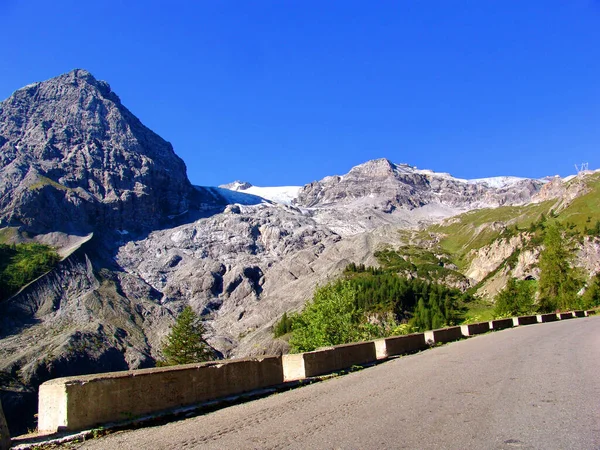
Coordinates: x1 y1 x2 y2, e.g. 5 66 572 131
0 70 576 432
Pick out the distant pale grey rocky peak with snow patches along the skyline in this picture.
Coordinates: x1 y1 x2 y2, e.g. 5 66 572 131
294 159 544 235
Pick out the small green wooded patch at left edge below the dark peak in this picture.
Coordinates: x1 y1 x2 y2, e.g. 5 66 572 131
0 243 60 300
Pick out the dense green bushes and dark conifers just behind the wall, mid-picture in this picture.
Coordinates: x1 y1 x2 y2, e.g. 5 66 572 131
274 264 472 352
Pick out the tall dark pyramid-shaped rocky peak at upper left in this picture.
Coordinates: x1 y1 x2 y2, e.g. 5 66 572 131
0 69 192 233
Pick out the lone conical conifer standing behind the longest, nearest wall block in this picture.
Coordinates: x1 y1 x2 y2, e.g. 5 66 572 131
161 306 213 366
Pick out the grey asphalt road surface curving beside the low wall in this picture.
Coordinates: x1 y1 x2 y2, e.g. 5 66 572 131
78 317 600 449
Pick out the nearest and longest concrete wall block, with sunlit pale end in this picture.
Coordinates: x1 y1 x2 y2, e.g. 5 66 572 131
38 357 283 432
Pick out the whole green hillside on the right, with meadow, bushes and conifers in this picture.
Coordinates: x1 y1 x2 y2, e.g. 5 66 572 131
274 174 600 351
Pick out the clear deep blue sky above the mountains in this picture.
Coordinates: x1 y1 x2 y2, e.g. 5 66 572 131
0 0 600 186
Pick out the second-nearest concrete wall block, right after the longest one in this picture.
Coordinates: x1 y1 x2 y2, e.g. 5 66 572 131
282 341 377 381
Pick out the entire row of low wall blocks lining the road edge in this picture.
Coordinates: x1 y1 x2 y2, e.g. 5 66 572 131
35 311 595 436
